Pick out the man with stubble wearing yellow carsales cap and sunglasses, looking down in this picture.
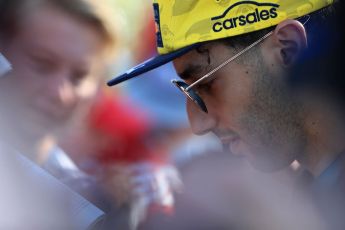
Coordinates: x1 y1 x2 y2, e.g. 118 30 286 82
108 0 345 229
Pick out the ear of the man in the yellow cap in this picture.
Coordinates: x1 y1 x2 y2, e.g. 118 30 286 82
272 19 307 67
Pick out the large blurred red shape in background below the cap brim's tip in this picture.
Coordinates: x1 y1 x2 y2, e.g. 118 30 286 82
88 92 163 164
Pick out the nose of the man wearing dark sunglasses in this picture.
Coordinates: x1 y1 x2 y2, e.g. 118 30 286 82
187 100 217 135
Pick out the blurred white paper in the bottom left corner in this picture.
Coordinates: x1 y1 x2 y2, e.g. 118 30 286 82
0 152 104 230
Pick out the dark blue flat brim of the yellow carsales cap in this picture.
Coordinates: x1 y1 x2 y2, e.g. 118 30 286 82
107 43 200 86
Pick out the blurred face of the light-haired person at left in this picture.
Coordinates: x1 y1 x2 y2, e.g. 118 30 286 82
0 6 103 139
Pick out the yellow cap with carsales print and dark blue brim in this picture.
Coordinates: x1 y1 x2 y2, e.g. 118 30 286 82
108 0 333 86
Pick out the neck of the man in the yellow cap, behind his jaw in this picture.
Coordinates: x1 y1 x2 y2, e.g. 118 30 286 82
298 90 345 177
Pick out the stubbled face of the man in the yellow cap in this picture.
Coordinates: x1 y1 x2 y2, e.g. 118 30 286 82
174 20 305 171
